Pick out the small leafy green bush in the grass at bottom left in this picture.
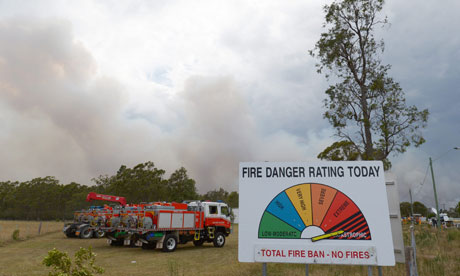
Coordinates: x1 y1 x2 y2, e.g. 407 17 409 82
42 247 104 276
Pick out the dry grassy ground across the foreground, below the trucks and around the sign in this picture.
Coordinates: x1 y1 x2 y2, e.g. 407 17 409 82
0 222 460 276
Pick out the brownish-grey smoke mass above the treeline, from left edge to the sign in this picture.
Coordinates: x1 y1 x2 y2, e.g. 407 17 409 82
0 19 320 192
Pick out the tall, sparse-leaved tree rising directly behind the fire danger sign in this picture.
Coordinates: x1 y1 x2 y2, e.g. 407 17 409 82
310 0 429 169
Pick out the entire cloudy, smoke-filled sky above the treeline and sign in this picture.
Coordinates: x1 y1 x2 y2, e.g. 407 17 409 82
0 0 460 208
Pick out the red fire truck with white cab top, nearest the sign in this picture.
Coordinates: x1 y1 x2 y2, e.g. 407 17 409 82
104 201 231 252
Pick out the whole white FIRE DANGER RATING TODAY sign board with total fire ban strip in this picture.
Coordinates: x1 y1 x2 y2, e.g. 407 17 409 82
238 161 395 266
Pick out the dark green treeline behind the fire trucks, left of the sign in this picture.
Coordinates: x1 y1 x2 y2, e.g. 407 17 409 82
0 162 238 220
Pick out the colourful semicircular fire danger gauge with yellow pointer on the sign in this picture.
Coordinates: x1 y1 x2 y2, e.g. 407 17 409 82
259 183 371 242
